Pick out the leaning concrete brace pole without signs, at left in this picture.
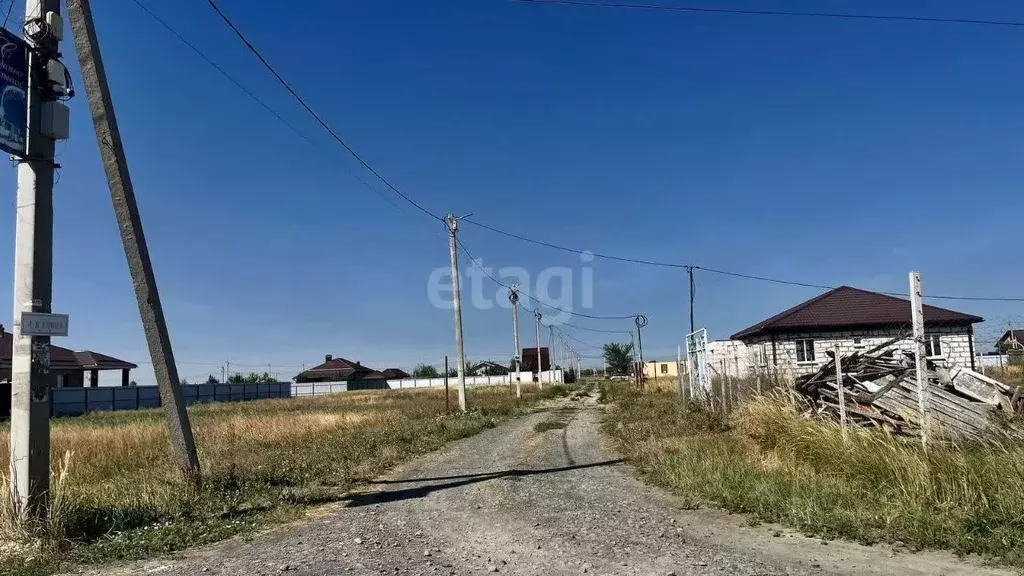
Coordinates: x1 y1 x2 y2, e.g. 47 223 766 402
68 0 200 477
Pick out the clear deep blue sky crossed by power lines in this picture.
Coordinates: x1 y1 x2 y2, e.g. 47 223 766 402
0 0 1024 383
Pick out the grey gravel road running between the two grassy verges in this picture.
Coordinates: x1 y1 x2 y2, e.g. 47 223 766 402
93 398 1013 576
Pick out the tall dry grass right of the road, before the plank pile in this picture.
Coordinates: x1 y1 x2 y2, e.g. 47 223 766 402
604 381 1024 566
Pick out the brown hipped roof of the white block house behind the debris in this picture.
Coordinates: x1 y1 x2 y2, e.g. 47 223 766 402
732 286 984 340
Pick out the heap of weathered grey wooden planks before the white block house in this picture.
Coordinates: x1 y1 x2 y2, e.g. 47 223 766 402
797 338 1024 439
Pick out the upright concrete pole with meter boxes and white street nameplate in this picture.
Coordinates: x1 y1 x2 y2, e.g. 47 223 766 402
9 0 62 523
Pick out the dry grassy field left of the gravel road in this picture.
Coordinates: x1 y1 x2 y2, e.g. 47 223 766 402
0 385 557 575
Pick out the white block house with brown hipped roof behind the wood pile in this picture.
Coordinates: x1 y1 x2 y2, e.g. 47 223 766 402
732 286 984 375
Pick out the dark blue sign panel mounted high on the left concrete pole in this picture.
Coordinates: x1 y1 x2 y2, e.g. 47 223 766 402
0 29 29 158
